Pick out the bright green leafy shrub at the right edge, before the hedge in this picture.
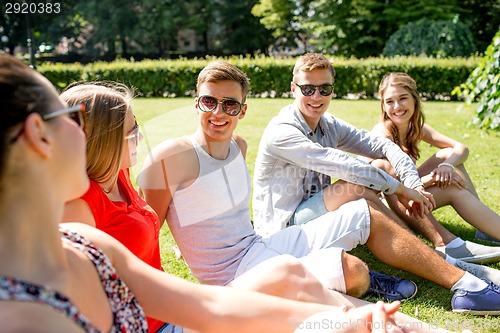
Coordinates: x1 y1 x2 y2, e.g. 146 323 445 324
453 30 500 131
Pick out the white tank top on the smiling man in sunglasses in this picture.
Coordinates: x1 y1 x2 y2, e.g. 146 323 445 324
167 137 260 285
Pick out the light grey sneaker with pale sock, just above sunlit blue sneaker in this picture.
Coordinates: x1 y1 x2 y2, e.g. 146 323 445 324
436 241 500 264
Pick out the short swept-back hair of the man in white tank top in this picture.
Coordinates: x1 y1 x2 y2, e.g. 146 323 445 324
196 60 250 103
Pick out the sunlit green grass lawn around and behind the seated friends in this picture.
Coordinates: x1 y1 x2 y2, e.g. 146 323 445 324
132 98 500 332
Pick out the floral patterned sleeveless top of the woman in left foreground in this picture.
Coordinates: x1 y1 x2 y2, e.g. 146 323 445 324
0 227 148 333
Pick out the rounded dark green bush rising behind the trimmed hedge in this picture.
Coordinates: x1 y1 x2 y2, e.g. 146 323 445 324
383 18 474 58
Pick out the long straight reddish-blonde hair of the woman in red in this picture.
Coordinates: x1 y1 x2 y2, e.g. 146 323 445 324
61 82 133 184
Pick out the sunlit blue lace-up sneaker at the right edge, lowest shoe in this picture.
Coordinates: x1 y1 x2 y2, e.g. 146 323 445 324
451 279 500 316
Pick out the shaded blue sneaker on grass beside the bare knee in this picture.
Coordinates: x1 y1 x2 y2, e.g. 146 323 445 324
367 271 417 301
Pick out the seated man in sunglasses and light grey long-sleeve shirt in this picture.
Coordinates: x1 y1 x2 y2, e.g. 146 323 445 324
253 53 500 311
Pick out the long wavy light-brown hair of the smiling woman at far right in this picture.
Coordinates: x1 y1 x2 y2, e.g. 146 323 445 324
378 72 425 159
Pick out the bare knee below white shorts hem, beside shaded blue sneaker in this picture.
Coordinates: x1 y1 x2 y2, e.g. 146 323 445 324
342 252 370 297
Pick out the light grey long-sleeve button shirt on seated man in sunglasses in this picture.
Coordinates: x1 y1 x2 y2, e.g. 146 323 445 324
252 104 423 237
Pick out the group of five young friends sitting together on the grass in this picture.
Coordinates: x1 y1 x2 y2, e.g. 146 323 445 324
0 53 500 333
